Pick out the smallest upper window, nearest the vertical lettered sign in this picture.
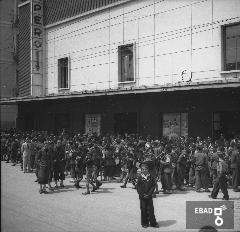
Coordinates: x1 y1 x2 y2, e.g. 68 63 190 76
58 57 69 89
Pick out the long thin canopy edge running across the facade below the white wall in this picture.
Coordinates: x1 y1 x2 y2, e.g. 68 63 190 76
0 78 240 105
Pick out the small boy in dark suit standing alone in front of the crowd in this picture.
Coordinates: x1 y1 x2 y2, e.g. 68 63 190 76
136 163 159 228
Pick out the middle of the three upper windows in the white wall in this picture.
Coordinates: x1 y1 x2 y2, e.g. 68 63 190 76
118 44 134 82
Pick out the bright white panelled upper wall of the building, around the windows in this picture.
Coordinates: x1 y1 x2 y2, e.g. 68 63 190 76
45 0 240 94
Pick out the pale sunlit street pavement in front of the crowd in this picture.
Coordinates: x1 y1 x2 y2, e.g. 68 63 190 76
1 161 240 232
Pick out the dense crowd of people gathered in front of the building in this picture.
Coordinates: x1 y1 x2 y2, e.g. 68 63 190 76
1 130 240 200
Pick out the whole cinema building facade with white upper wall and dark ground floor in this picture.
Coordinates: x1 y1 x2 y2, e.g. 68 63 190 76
1 0 240 137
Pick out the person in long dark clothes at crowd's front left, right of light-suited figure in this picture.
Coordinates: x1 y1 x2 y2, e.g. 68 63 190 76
37 141 51 194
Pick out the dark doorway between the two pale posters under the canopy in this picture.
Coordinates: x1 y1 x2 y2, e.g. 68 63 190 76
114 112 137 134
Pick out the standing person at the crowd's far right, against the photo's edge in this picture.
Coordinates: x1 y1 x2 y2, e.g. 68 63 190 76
230 140 240 192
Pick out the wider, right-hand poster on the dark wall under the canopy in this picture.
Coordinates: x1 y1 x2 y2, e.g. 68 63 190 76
163 113 188 138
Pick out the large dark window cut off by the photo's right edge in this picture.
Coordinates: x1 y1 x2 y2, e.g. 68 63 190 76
223 23 240 71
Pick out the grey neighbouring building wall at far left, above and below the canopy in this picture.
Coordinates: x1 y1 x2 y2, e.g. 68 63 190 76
0 0 17 128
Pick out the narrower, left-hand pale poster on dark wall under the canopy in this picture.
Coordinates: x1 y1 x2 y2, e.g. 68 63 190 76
85 114 101 135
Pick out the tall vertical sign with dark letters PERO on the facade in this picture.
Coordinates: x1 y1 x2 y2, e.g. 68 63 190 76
31 0 44 96
